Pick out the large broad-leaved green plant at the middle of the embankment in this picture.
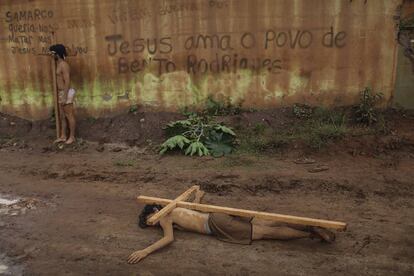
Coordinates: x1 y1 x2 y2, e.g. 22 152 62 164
160 113 236 157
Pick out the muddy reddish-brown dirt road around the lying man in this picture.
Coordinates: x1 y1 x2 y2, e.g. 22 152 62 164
0 110 414 275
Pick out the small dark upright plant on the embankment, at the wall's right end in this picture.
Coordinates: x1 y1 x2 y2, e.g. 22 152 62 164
354 87 383 125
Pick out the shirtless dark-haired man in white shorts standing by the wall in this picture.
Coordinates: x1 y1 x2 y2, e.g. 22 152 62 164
49 44 76 145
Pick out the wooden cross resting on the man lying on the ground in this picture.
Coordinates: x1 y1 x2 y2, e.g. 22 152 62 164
137 186 347 230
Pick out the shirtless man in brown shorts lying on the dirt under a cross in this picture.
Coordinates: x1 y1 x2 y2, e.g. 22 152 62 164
128 190 335 264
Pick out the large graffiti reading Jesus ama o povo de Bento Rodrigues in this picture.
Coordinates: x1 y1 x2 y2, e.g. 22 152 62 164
105 26 346 75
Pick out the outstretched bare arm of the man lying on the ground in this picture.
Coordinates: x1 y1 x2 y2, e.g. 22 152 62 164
128 216 174 264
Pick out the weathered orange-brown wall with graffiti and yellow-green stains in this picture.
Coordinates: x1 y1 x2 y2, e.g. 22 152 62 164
0 0 401 119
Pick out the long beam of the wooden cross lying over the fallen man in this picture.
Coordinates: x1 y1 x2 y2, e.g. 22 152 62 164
137 196 347 230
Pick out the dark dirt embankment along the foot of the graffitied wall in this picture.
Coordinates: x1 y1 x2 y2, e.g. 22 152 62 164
0 108 414 155
